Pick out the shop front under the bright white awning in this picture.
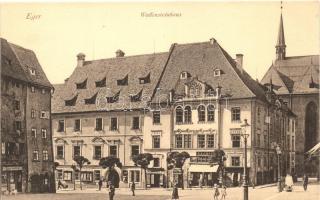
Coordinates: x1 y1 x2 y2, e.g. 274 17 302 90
188 164 219 187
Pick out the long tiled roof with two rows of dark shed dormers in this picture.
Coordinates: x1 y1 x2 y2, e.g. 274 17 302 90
52 53 168 113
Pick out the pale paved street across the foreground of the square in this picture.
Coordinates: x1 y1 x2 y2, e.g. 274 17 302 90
2 184 320 200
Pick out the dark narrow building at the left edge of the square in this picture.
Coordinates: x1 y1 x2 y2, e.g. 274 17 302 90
1 38 55 192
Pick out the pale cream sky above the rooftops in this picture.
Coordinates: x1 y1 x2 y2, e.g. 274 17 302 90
0 1 320 84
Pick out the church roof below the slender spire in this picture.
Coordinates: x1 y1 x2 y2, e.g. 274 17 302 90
261 55 319 94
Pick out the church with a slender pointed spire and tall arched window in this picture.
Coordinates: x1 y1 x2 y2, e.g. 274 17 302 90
261 14 320 175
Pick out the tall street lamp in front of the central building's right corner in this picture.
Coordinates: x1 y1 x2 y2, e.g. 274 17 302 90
241 119 250 200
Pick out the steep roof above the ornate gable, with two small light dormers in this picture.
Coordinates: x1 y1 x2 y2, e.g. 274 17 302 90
157 42 265 100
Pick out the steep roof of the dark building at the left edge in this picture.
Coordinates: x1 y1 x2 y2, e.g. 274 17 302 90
1 38 52 87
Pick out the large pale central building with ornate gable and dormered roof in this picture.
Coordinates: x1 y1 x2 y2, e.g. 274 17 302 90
52 39 295 187
